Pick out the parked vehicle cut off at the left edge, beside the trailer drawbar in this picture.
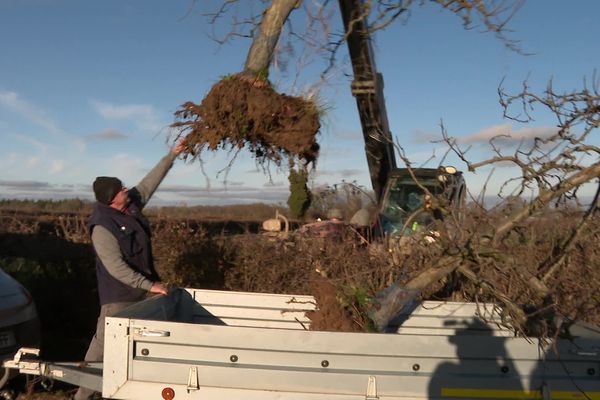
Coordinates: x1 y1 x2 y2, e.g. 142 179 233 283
0 269 40 388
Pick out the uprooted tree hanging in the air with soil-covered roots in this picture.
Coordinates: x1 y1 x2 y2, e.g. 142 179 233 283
172 0 518 172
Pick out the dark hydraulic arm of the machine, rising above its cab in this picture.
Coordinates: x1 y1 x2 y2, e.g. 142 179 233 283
339 0 396 203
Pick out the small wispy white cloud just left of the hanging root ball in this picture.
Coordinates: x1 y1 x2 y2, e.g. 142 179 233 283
91 100 163 132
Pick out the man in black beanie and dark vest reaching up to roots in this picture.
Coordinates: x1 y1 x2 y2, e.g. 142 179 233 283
74 143 183 400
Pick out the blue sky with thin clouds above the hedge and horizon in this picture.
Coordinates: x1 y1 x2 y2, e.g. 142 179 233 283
0 0 600 205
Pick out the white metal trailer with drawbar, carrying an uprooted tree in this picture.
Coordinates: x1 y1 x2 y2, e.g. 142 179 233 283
5 289 600 400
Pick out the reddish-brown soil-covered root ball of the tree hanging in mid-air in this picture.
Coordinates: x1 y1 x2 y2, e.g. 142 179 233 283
171 74 321 165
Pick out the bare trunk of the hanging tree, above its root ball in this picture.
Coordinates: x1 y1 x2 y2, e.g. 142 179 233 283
244 0 302 78
